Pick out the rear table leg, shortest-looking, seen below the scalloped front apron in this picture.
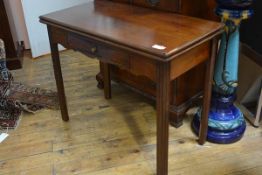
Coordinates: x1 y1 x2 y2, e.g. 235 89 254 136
102 63 111 99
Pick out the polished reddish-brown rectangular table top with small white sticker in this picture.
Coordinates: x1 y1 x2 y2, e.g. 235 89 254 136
40 0 223 59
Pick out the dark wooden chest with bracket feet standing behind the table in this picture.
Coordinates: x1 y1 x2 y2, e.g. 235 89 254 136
96 0 219 127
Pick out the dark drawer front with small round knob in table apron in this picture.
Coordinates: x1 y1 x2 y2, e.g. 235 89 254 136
68 33 130 69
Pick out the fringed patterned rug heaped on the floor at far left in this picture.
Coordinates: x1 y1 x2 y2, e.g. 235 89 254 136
0 39 59 129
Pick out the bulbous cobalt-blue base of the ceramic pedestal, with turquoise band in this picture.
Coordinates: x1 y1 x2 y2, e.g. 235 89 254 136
192 93 246 144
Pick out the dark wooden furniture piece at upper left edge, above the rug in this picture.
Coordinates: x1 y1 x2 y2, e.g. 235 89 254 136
0 0 24 70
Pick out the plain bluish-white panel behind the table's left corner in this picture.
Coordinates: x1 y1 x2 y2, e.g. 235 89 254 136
22 0 90 57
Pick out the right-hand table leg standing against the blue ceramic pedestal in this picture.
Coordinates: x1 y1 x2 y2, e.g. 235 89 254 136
198 38 218 145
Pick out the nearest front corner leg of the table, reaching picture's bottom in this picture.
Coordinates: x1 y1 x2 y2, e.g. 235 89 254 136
156 63 170 175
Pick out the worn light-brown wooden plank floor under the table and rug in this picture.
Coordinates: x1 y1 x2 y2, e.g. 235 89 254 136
0 51 262 175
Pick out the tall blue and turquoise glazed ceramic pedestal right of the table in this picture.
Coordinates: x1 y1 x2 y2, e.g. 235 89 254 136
192 0 253 144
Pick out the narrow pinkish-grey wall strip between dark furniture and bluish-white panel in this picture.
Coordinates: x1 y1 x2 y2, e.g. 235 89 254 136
4 0 30 49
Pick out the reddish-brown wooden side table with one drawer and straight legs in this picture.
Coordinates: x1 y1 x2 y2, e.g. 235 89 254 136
40 0 223 175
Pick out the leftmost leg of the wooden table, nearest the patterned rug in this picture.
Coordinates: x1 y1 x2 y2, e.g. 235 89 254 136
48 28 69 121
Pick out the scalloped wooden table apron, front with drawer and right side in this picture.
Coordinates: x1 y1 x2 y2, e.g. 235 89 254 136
51 26 210 82
